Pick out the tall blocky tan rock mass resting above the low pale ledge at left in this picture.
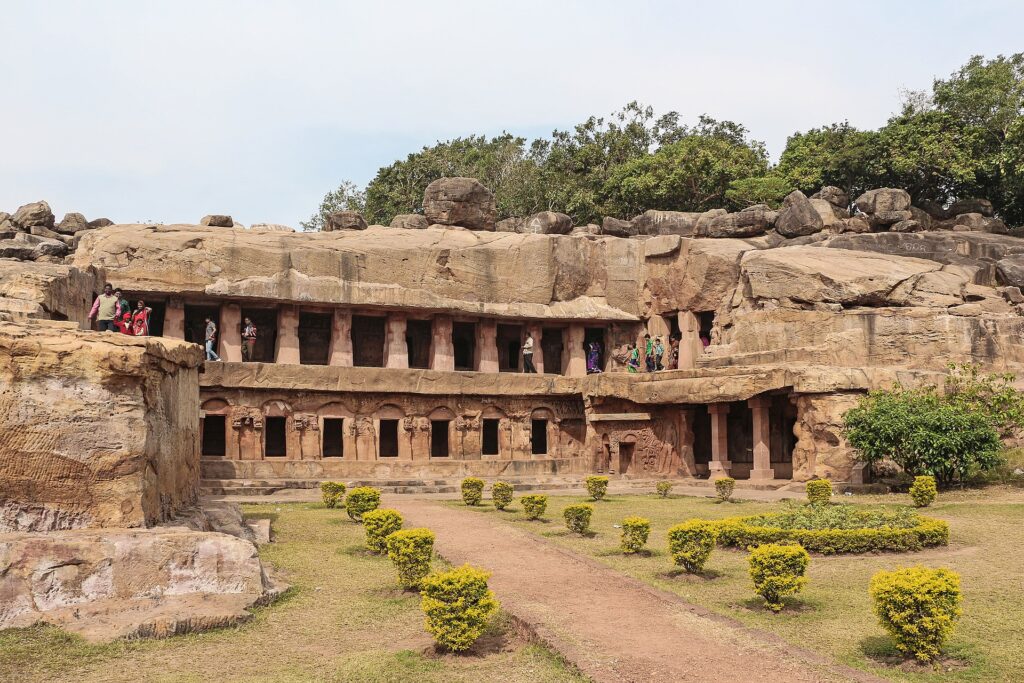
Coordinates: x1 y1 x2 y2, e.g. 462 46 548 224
0 321 201 531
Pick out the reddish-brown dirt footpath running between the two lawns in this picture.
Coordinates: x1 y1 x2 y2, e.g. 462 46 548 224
387 496 879 683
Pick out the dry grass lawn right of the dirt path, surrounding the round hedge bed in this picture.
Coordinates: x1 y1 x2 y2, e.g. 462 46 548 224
451 487 1024 682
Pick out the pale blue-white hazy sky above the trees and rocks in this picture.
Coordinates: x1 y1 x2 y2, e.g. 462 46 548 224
0 0 1024 226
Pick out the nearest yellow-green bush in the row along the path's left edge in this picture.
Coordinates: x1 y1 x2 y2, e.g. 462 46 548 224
420 564 498 652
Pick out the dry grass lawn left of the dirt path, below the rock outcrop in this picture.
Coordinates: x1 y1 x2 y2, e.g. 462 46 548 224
0 504 584 683
